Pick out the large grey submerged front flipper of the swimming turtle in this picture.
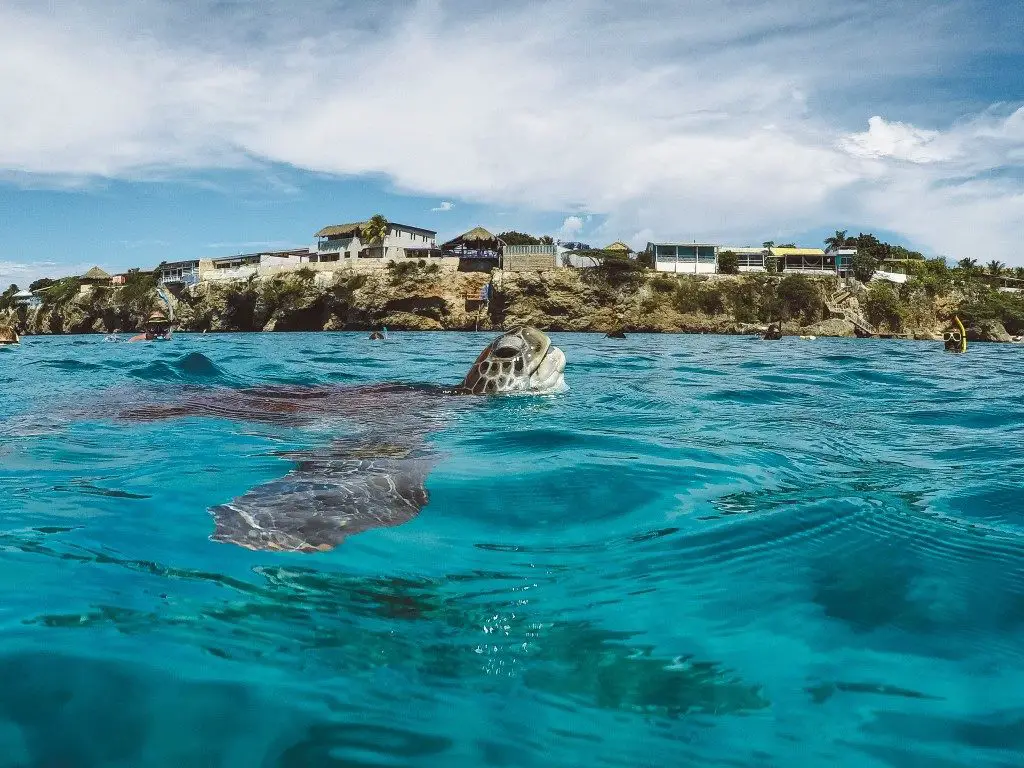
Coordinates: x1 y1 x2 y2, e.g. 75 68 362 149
210 440 436 552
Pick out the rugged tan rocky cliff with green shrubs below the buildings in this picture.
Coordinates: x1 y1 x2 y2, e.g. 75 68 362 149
6 262 1010 341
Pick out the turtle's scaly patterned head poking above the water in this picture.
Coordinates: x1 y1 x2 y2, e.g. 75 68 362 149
462 327 565 394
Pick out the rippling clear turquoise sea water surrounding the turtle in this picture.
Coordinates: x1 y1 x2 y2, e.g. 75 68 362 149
0 333 1024 768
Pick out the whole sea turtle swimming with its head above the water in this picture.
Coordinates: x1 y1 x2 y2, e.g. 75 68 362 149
121 328 565 552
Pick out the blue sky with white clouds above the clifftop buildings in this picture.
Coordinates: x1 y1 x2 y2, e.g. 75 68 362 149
0 0 1024 285
